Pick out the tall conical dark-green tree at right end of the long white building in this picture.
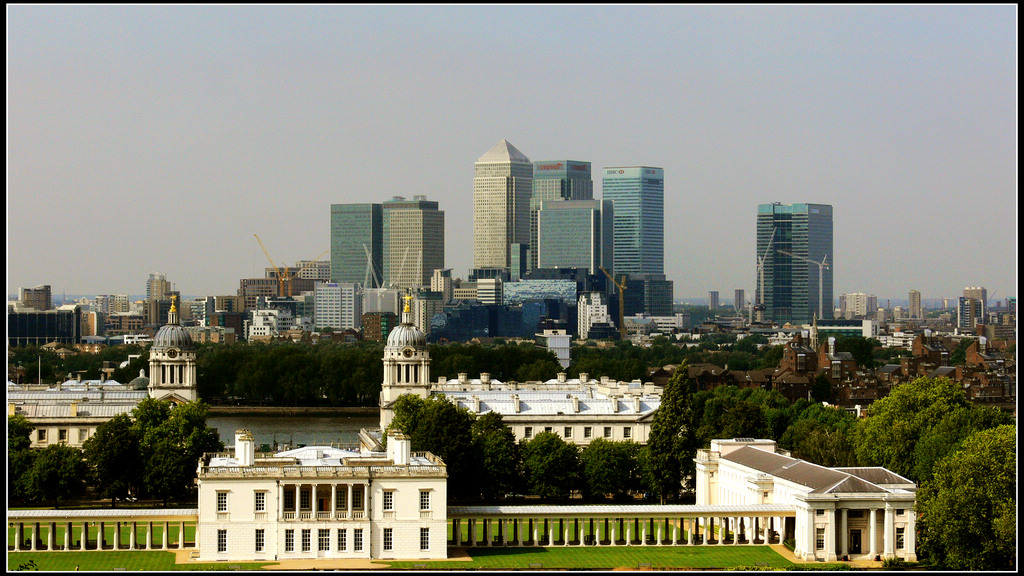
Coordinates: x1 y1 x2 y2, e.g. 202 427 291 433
644 362 696 504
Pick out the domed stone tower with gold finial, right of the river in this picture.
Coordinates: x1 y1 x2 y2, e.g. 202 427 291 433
381 294 430 430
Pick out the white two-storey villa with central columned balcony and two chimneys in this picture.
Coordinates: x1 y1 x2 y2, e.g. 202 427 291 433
196 430 447 562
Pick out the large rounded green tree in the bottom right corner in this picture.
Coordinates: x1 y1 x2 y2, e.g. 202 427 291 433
918 425 1017 572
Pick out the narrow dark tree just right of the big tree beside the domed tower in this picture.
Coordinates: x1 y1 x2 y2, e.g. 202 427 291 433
472 412 522 500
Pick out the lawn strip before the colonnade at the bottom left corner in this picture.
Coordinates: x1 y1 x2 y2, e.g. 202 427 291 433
7 550 273 572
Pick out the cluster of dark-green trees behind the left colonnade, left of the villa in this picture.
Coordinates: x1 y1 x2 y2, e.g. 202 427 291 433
7 398 223 507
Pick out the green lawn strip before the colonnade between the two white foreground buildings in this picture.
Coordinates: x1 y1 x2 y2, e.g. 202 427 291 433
387 545 794 570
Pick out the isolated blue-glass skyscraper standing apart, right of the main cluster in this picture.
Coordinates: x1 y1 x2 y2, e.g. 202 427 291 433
757 203 835 324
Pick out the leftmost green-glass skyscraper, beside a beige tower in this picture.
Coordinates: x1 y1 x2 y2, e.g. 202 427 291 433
331 204 384 287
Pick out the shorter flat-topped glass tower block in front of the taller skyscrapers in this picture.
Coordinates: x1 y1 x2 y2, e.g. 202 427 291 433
534 200 614 274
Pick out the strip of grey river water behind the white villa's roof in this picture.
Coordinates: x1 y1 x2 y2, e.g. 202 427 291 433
207 414 380 451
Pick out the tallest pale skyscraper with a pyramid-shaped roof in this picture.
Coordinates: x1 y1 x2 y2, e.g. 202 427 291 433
473 139 534 269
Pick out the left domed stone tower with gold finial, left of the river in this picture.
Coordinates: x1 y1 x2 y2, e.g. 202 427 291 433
148 299 198 404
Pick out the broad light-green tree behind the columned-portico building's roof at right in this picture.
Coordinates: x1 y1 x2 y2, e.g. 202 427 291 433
854 378 1012 482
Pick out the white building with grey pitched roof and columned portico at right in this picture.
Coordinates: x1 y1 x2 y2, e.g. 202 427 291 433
695 439 916 562
